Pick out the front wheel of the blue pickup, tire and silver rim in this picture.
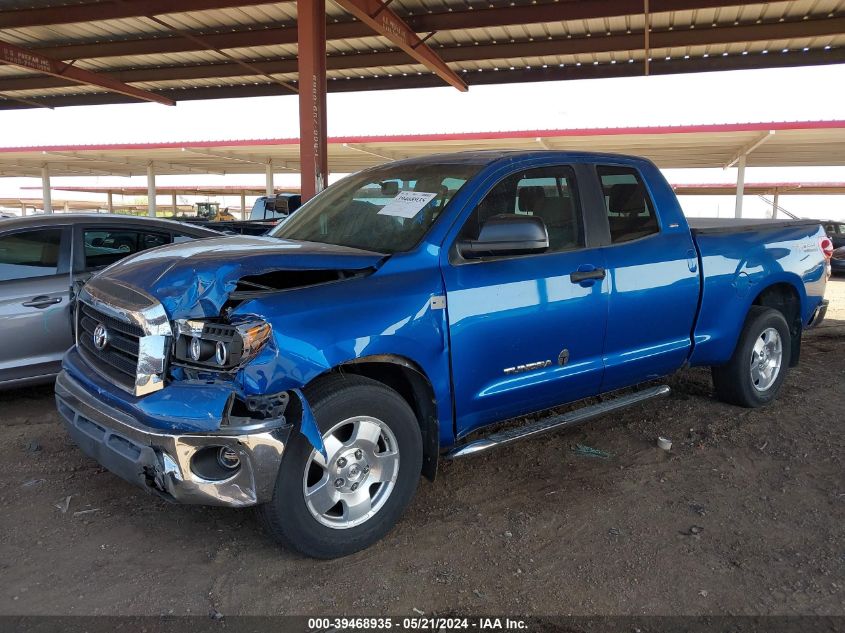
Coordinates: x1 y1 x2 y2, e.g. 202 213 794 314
259 375 422 558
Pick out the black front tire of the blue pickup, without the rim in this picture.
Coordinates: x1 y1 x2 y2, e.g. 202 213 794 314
258 374 422 559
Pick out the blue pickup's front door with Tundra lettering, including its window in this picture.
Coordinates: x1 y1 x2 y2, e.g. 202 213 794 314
443 165 608 437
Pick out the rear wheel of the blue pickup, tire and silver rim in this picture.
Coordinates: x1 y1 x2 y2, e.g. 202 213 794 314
712 306 792 407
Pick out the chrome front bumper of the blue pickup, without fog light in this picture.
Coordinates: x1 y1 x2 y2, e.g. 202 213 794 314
56 372 291 507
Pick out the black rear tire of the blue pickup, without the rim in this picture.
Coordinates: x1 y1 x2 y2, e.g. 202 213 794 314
712 306 792 408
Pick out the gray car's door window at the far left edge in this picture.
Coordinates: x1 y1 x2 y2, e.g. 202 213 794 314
0 229 62 281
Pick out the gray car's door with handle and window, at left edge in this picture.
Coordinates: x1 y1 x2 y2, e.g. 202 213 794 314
0 225 72 382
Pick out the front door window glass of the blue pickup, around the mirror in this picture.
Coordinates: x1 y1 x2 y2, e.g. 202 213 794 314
460 166 584 252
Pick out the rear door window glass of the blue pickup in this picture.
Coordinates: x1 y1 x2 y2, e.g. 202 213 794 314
597 165 660 244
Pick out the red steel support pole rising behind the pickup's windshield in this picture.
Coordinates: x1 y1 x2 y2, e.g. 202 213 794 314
296 0 329 201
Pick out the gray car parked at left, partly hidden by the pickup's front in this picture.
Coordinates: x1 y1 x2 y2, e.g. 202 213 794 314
0 214 220 388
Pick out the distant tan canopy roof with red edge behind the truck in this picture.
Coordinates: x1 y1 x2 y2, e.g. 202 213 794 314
0 121 845 177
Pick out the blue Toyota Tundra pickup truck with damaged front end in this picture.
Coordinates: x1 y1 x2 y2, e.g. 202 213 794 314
56 152 827 558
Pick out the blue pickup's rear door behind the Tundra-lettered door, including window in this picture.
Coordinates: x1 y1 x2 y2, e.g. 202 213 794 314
596 165 699 391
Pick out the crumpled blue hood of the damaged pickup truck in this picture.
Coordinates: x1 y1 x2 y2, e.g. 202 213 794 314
92 235 386 318
